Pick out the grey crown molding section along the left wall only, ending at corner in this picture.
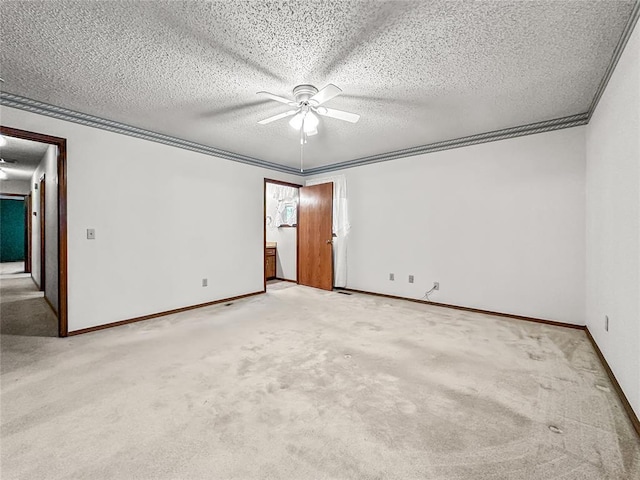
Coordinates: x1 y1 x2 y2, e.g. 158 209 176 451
0 92 300 175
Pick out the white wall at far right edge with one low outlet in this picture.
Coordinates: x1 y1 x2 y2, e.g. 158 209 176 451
586 27 640 416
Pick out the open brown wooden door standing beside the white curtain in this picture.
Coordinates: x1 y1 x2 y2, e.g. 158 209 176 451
298 183 333 290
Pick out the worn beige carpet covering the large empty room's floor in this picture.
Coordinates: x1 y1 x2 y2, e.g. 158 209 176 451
1 285 640 480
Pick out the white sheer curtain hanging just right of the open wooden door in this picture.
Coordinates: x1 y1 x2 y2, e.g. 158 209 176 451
306 175 351 287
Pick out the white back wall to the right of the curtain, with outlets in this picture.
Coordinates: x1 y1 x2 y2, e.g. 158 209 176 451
312 127 585 325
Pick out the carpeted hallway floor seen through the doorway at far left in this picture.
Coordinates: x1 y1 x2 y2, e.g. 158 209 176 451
0 262 58 338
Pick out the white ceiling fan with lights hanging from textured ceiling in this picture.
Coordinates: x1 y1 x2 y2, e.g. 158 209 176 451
258 83 360 137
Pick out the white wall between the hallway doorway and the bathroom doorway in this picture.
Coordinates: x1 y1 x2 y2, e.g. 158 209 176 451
2 107 301 331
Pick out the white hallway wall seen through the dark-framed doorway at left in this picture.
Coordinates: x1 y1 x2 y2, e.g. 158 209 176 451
30 145 58 312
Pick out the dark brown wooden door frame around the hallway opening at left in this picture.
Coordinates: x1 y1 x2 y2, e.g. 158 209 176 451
0 125 69 337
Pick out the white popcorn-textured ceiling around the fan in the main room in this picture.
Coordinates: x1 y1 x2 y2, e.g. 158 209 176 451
0 0 633 171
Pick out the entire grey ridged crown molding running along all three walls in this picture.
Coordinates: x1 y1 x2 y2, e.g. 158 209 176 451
0 0 640 177
